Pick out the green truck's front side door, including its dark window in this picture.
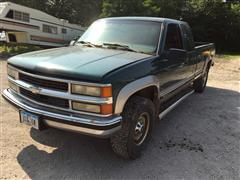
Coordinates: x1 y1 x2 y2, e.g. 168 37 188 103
159 22 193 91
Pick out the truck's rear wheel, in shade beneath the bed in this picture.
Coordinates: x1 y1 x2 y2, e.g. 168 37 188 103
193 66 210 93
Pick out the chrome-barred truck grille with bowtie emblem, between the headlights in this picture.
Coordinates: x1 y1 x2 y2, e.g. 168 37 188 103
8 67 112 117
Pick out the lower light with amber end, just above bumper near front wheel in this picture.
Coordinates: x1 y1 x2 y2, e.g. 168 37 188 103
72 101 112 115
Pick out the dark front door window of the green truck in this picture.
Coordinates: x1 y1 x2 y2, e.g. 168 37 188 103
165 24 183 50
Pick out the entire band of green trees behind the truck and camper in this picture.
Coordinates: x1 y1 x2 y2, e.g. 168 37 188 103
3 0 240 52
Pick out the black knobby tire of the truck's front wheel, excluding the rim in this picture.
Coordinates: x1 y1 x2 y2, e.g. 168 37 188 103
111 96 155 159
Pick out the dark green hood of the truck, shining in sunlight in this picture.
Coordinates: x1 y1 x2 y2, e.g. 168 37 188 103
8 46 151 82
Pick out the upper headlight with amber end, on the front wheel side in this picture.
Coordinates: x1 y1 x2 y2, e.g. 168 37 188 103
71 84 112 97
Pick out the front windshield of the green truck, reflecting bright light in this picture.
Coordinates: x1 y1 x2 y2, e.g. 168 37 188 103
78 20 161 53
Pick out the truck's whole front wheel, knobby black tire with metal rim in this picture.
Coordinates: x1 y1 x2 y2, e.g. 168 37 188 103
111 96 155 159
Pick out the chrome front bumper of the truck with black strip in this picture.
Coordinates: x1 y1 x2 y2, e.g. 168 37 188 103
2 89 122 138
